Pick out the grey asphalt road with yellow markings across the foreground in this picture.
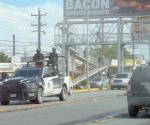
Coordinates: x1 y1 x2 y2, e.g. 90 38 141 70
0 90 150 125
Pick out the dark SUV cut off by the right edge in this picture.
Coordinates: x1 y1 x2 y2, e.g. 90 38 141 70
127 66 150 117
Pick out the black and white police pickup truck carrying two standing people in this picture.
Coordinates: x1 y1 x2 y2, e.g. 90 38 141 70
0 63 71 105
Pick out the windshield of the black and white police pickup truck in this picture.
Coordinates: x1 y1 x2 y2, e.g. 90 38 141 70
14 69 41 77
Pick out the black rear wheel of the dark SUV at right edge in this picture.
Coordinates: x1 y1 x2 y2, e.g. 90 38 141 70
128 106 139 117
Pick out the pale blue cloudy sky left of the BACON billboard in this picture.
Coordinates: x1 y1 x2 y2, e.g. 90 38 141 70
0 0 63 56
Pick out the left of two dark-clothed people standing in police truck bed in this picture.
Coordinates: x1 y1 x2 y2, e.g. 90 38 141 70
33 49 44 65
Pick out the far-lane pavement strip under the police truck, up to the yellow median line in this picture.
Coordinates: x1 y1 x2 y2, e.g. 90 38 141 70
0 90 125 112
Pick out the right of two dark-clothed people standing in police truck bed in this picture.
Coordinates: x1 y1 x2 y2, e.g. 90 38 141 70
48 48 58 73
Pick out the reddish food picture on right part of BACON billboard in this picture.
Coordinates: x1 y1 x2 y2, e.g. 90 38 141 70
112 0 150 16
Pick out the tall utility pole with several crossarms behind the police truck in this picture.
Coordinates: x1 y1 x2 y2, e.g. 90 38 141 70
31 8 46 50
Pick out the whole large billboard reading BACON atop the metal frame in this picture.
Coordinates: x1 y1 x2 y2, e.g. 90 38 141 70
64 0 150 19
